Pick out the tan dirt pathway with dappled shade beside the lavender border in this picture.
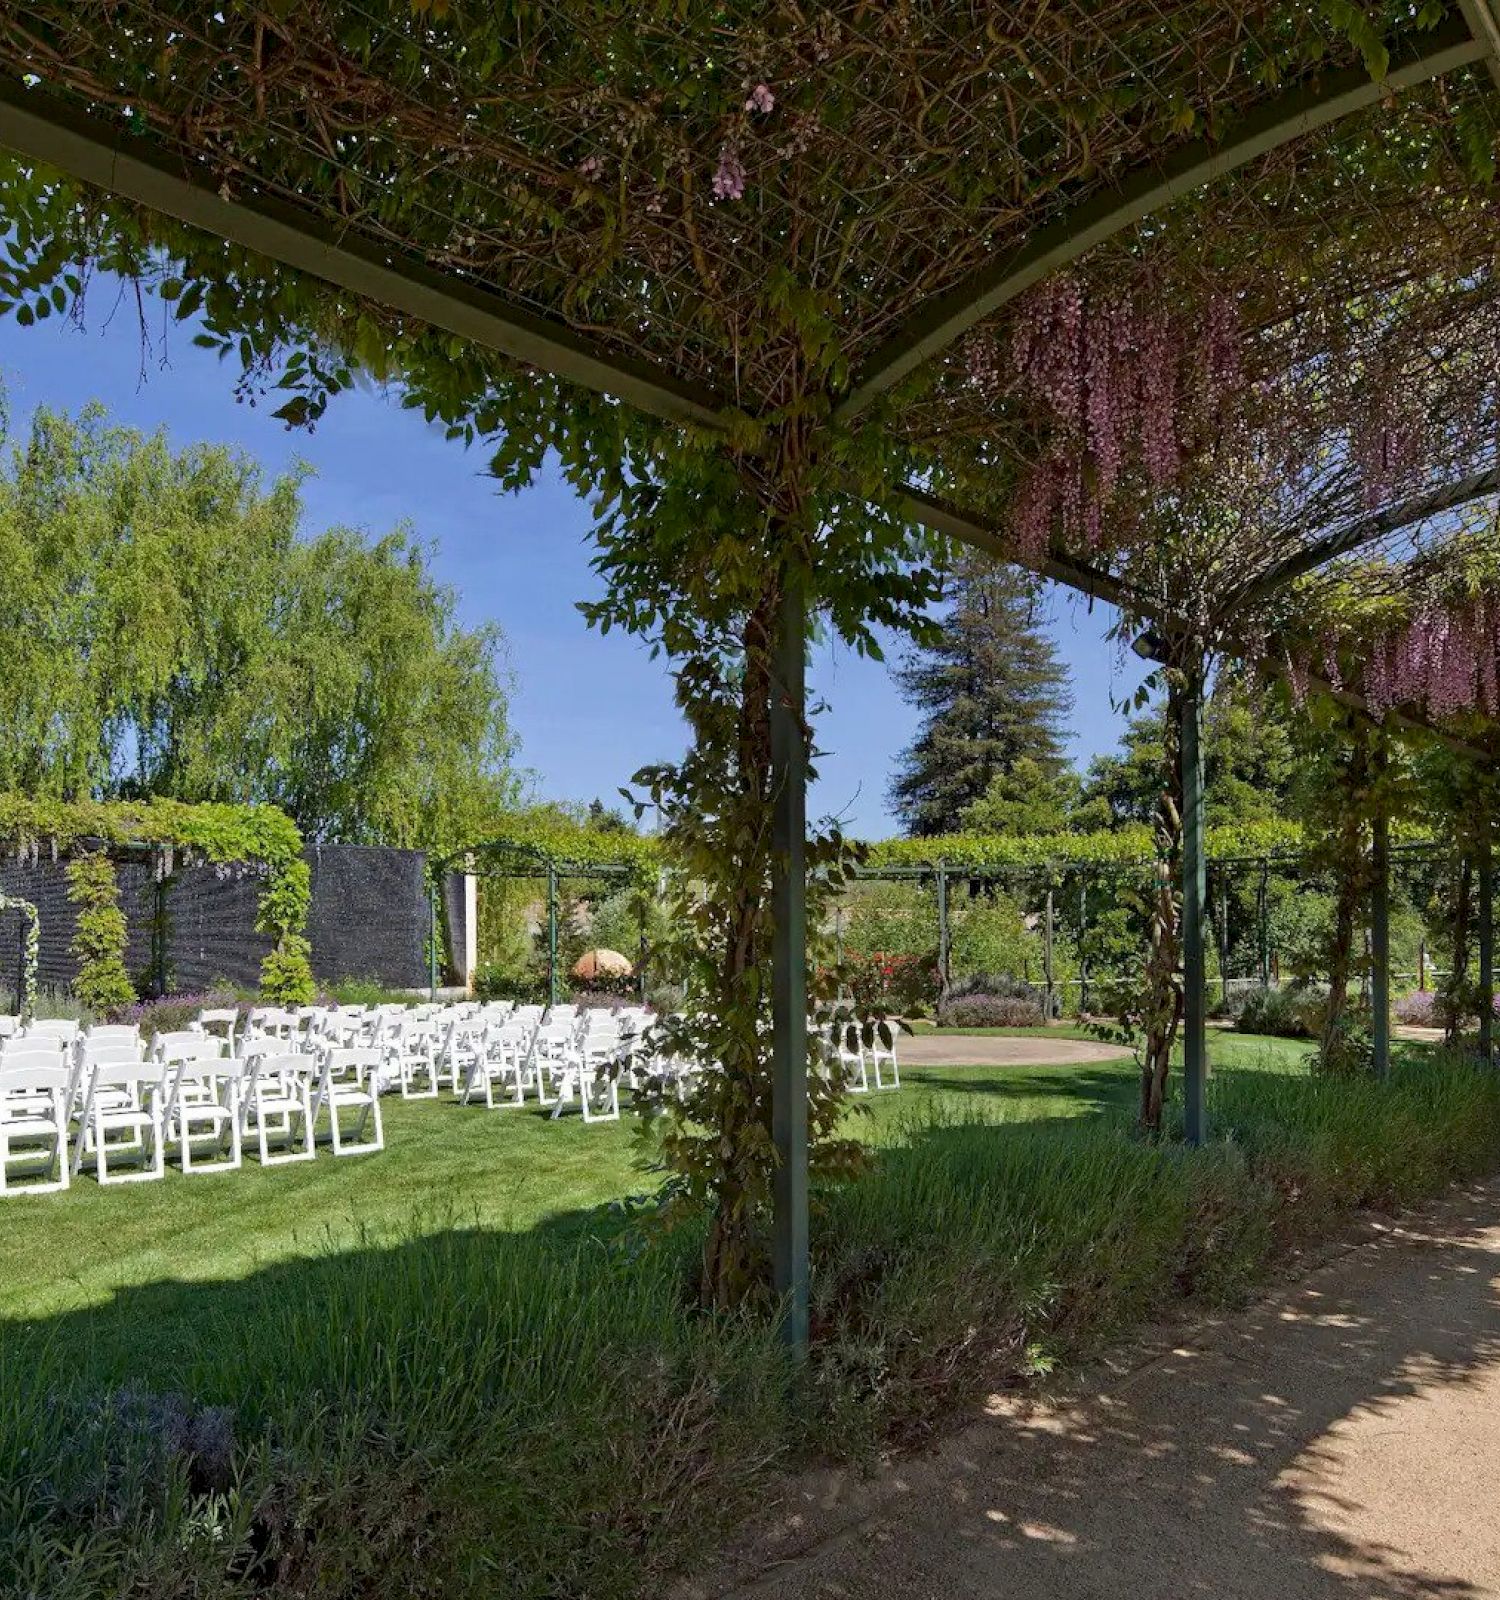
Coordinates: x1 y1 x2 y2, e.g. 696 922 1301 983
688 1181 1500 1600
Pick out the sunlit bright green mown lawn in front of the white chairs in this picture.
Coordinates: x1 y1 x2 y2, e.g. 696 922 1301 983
0 1030 1310 1341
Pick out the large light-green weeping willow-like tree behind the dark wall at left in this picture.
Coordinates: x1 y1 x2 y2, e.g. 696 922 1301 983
0 408 513 845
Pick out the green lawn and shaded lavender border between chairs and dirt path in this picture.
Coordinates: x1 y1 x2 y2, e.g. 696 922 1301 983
0 1035 1500 1600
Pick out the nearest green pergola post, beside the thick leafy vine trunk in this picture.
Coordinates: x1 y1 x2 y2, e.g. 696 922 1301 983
771 573 808 1357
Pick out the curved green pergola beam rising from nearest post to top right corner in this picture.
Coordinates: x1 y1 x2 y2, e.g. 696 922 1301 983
833 15 1490 421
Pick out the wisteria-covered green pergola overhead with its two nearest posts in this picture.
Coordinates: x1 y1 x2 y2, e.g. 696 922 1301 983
0 0 1500 1342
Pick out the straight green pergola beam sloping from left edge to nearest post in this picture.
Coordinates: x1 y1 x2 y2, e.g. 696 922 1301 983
0 80 723 429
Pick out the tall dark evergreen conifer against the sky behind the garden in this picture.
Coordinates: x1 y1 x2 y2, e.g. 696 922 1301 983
891 557 1073 834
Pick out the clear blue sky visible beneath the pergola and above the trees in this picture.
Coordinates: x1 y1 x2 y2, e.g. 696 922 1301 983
0 297 1139 837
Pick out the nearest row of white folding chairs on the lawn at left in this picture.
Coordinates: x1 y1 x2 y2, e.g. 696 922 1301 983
0 1026 385 1194
